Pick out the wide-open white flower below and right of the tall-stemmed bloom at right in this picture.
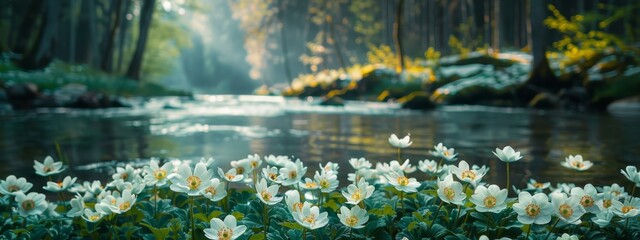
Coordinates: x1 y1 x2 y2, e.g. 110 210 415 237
513 192 553 225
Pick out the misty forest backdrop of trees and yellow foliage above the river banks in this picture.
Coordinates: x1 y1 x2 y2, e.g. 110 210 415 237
0 0 640 98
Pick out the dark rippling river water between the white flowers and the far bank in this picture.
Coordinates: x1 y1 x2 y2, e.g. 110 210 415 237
0 96 640 190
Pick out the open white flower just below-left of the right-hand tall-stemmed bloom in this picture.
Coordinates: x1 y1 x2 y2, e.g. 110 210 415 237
469 185 507 213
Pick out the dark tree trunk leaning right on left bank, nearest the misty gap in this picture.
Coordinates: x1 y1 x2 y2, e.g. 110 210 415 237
126 0 156 80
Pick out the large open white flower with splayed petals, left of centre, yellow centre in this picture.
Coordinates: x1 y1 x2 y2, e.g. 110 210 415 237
170 163 211 196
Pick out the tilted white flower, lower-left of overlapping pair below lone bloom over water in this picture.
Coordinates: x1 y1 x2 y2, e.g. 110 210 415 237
551 193 586 224
